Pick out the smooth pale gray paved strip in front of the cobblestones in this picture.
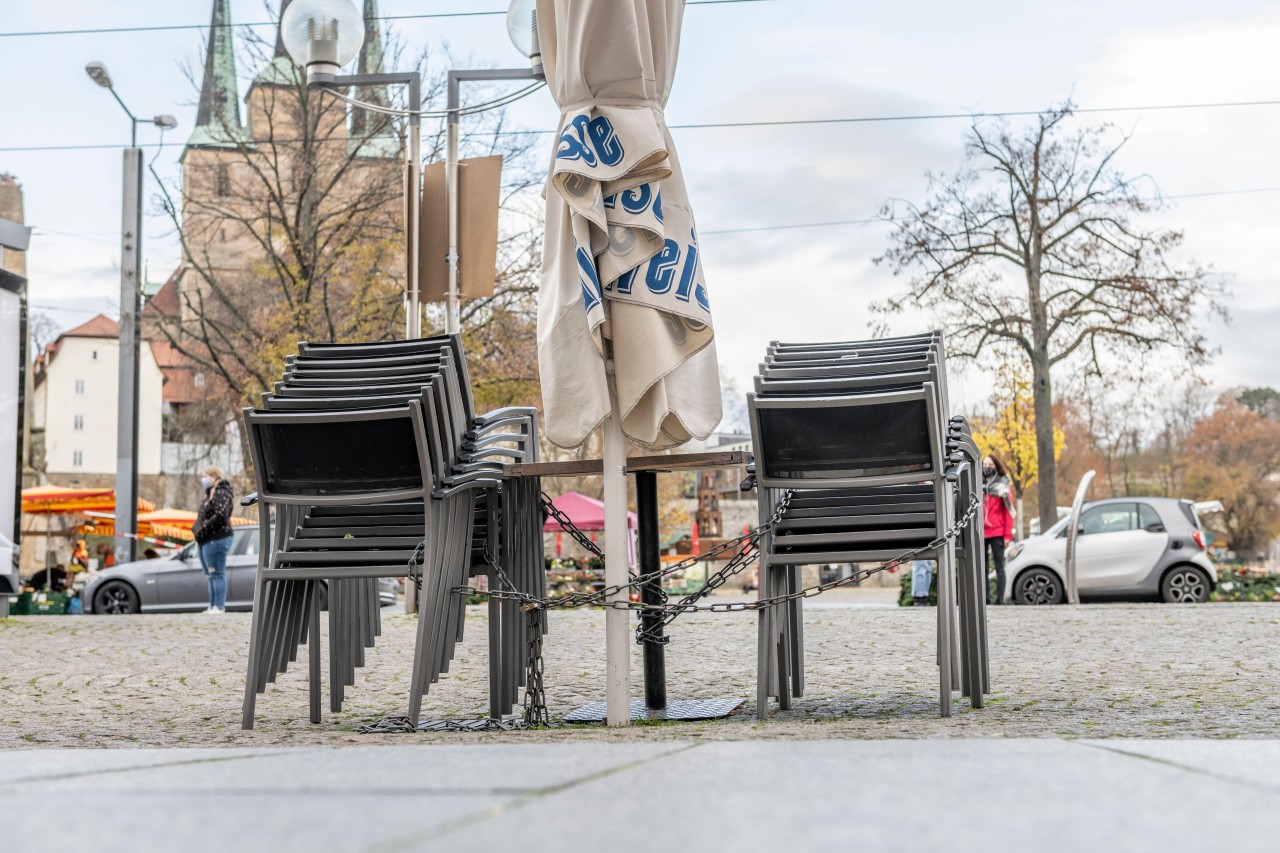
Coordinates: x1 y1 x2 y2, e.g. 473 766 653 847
0 739 1280 853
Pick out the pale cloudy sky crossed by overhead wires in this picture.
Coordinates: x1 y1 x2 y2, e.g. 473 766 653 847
0 0 1280 412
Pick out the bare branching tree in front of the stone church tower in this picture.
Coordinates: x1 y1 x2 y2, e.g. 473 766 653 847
153 33 540 420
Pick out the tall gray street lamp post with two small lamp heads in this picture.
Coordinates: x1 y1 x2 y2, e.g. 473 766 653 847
84 61 178 562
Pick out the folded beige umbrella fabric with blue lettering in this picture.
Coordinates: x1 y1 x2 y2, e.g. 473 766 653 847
538 0 721 450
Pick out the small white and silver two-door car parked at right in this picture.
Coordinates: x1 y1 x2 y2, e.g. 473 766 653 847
1005 497 1220 605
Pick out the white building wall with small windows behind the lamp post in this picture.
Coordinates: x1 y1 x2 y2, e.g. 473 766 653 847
37 338 164 475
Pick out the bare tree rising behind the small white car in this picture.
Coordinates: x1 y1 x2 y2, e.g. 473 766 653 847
876 104 1222 529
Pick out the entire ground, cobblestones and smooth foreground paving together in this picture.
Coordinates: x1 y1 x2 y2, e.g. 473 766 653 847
0 590 1280 853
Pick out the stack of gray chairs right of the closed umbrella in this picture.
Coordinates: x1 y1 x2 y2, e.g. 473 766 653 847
748 333 989 719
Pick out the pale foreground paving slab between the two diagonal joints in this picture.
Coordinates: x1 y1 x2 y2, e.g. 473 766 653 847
427 740 1280 853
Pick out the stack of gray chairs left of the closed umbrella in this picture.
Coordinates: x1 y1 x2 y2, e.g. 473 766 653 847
243 336 544 727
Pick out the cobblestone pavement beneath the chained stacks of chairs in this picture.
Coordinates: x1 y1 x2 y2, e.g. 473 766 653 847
0 599 1280 748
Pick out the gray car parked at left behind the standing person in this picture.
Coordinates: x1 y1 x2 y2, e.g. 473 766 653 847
81 525 397 615
